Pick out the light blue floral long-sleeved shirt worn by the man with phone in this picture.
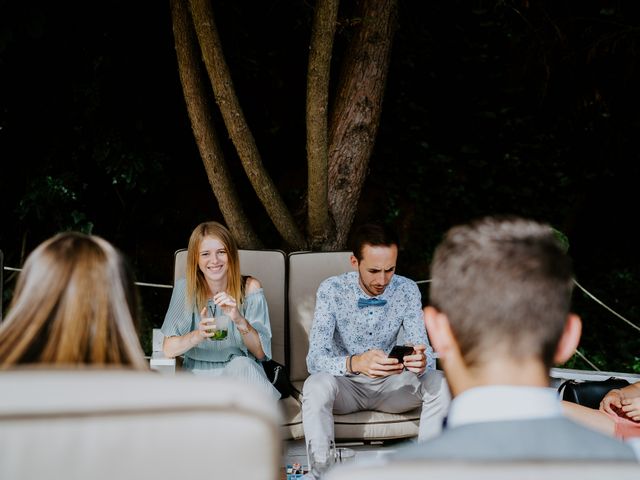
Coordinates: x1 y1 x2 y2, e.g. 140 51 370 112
307 272 435 376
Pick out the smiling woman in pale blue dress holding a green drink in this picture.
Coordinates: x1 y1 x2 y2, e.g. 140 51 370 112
161 222 280 398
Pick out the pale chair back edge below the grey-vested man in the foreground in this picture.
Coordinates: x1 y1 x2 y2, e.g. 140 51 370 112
326 460 640 480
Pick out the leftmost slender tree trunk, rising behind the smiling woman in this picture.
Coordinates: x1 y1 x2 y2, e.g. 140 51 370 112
171 0 262 248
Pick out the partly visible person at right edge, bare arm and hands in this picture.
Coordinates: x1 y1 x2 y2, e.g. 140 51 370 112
562 383 640 440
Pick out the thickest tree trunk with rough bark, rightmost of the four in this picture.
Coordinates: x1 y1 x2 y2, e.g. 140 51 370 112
329 0 397 248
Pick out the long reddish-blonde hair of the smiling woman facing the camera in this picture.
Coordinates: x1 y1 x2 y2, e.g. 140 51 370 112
186 222 244 312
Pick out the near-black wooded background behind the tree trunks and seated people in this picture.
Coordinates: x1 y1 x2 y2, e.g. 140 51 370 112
0 0 640 372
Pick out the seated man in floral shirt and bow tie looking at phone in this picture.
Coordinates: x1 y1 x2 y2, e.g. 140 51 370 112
302 224 450 464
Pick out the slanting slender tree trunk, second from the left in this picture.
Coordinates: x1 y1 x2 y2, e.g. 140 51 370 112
189 0 306 248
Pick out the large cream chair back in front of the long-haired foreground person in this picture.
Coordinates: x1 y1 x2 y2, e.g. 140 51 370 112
0 369 282 480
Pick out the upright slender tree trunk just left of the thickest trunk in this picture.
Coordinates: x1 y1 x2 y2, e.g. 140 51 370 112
306 0 339 248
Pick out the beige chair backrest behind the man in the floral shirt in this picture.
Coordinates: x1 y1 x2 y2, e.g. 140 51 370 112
288 251 353 381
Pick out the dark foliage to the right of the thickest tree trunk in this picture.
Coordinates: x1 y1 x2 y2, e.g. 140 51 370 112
360 0 640 371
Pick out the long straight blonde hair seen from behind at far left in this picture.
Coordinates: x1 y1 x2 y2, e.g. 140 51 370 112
0 232 148 370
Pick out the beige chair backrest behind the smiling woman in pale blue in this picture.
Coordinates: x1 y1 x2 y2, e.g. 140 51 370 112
173 248 287 364
